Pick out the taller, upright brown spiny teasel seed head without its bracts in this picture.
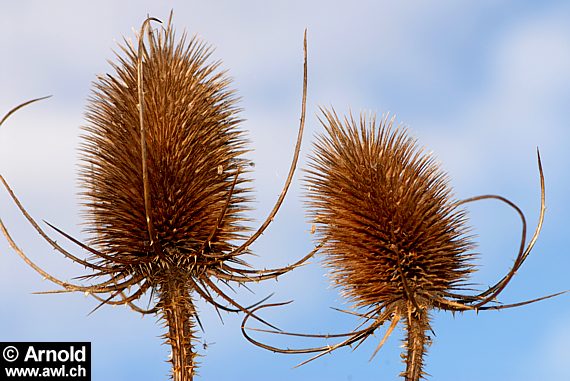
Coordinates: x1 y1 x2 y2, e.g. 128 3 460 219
80 20 247 276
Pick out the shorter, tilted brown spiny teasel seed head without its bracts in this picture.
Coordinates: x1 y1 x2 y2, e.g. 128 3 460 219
306 107 473 307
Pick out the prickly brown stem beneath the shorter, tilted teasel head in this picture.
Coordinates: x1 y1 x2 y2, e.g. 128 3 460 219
401 301 430 381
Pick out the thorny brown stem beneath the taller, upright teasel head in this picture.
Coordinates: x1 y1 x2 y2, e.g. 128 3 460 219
159 277 196 381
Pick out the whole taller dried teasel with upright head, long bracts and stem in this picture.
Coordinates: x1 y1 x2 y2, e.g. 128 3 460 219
0 18 314 381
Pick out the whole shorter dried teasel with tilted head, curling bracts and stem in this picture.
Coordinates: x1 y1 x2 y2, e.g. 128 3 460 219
242 110 558 381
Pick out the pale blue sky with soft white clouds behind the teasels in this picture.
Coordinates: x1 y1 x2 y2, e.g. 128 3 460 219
0 0 570 381
